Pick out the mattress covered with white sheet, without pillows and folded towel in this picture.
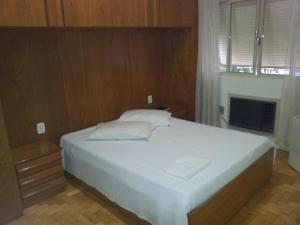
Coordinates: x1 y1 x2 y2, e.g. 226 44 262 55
61 118 273 225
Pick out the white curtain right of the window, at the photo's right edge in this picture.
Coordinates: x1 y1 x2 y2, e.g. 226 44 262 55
276 0 300 150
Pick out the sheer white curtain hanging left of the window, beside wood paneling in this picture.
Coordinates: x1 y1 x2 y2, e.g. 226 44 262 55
196 0 220 126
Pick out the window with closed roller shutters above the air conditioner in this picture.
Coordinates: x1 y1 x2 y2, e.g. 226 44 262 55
219 0 292 75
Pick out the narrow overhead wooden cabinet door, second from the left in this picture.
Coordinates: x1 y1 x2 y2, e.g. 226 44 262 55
45 0 64 27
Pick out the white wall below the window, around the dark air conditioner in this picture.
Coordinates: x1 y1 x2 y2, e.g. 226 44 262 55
220 73 283 127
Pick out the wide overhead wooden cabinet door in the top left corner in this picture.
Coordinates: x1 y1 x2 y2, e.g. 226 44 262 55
0 0 47 27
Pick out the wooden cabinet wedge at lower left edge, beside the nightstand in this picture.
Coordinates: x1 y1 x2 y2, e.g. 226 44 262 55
0 102 22 224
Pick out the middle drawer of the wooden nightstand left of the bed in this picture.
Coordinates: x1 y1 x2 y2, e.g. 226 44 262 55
19 165 64 191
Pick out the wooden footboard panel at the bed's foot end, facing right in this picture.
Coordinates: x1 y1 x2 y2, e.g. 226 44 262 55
188 148 274 225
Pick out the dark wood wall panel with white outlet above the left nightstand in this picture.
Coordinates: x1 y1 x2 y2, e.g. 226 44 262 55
0 30 69 147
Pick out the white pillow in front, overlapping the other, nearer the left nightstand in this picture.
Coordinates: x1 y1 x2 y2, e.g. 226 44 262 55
88 121 152 140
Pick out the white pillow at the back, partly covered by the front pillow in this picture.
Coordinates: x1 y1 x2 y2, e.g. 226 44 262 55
119 109 172 128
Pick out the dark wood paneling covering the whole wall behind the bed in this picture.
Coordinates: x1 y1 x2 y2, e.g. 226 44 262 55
0 1 198 148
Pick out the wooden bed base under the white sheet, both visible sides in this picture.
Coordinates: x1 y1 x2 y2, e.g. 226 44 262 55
66 148 274 225
